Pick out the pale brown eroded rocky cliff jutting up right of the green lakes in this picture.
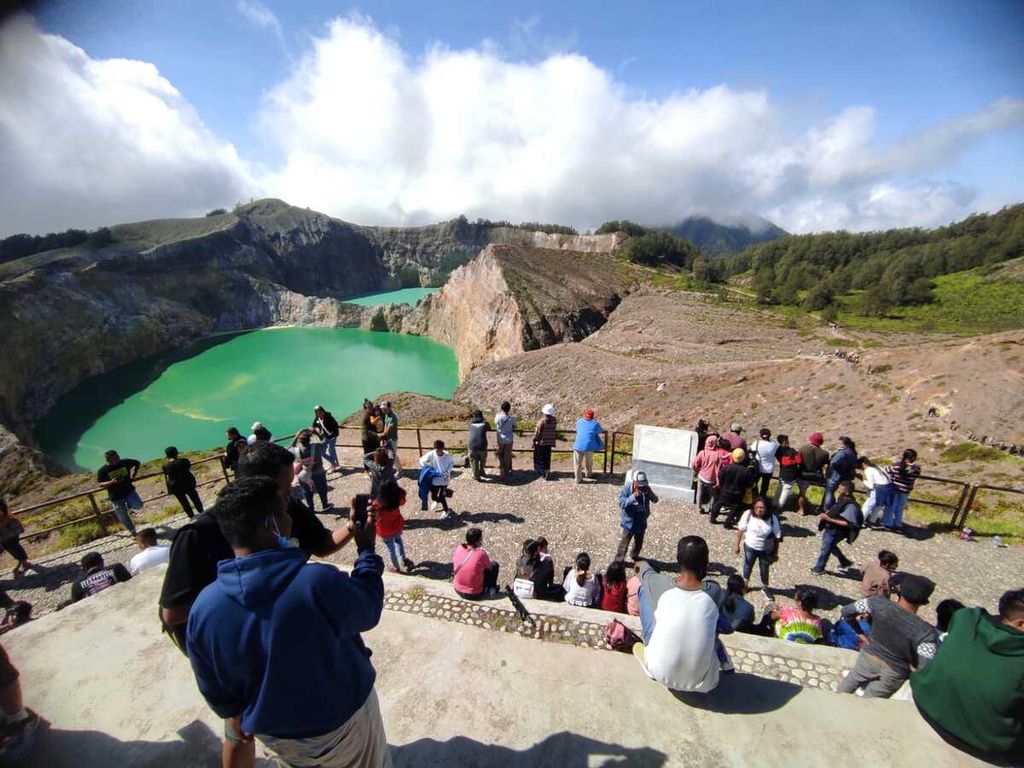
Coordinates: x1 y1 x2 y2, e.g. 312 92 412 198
401 245 633 377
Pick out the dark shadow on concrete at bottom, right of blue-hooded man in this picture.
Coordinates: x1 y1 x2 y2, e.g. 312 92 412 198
391 733 667 768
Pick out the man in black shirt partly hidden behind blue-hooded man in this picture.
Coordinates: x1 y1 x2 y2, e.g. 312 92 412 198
160 440 352 651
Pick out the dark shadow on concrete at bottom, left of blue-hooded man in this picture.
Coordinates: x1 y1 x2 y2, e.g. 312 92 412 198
24 720 276 768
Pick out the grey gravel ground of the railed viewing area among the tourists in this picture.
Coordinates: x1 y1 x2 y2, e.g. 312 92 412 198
0 456 1024 621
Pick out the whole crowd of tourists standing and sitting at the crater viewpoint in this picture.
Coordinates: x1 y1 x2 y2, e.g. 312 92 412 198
0 400 1024 766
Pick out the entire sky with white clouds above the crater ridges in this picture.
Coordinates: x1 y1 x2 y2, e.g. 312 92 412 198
0 0 1024 236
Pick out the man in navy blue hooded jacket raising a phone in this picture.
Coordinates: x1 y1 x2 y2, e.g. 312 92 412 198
186 477 391 768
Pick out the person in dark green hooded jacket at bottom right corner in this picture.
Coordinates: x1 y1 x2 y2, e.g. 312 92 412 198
910 589 1024 765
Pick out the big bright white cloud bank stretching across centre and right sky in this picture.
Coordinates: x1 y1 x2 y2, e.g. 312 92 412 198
262 16 1024 231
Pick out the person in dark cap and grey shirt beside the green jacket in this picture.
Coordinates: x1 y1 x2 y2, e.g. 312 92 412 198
839 573 939 698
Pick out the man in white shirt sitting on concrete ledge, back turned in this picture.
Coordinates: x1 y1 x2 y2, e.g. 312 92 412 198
633 536 721 693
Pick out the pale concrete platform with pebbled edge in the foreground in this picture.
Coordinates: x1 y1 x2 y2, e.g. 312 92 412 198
3 567 982 768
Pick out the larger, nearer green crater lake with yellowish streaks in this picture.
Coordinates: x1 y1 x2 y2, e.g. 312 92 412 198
36 328 459 470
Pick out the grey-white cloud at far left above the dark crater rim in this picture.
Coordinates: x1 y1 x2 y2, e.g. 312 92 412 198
0 16 251 234
